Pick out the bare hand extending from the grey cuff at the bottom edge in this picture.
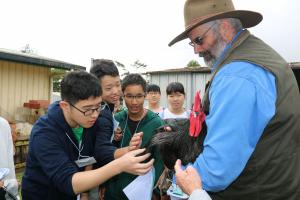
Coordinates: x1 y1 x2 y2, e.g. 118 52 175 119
174 159 202 195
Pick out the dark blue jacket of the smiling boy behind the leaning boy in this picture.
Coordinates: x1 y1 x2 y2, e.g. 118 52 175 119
95 104 117 167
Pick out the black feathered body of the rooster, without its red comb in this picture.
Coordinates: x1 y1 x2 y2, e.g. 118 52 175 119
145 119 207 170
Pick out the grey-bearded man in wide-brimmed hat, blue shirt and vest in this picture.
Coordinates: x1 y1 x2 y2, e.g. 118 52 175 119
169 0 300 200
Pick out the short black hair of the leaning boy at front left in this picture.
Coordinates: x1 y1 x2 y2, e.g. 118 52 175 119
60 71 102 104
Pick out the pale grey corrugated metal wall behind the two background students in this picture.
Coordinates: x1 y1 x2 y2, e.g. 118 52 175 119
150 72 210 108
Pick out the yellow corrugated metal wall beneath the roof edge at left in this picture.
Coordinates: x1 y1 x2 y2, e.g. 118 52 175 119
0 60 50 118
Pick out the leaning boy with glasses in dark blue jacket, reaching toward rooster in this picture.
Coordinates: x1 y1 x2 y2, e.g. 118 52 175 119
22 71 154 200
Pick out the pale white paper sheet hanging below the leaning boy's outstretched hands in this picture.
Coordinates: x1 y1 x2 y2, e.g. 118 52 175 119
123 167 155 200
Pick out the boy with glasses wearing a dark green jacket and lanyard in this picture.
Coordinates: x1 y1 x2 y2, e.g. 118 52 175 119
105 74 163 200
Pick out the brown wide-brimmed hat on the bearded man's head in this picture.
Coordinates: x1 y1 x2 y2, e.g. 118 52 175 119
169 0 263 46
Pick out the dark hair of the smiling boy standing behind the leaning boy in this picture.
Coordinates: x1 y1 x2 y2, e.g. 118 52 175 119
90 59 120 80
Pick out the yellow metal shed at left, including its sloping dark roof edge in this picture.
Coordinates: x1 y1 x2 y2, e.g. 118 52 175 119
0 49 86 119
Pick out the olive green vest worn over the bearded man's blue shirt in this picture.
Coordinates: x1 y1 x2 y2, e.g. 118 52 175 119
203 31 300 200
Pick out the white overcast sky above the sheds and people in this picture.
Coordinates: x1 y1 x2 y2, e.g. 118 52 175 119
0 0 300 70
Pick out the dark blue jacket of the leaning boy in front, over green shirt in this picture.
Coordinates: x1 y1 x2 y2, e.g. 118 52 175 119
22 102 99 200
